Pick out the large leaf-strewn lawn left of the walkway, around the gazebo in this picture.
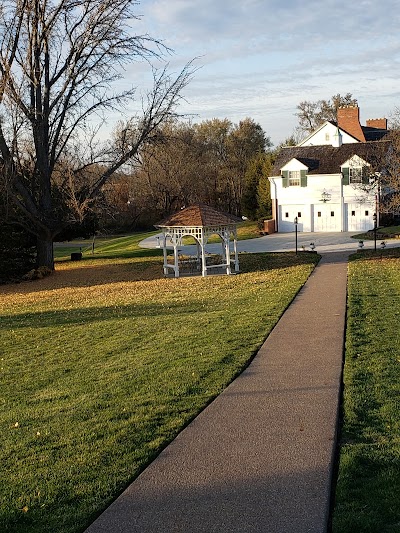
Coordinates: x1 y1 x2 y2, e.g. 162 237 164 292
0 237 316 533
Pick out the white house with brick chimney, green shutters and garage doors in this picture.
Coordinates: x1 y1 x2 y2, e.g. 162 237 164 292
269 106 387 232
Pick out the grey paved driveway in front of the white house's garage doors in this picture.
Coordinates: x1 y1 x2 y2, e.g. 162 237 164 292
140 232 400 255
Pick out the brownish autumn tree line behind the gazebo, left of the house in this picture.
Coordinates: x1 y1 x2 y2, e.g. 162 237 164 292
95 118 274 230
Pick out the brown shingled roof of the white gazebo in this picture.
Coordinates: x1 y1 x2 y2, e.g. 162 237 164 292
155 204 242 228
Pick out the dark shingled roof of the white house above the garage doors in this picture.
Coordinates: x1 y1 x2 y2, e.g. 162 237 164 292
272 141 389 176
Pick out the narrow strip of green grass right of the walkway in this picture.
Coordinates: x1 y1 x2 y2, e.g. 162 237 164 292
333 249 400 533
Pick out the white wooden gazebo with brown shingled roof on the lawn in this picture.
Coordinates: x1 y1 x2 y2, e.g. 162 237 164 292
155 205 241 278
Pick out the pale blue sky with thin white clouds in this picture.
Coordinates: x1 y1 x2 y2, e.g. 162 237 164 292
122 0 400 145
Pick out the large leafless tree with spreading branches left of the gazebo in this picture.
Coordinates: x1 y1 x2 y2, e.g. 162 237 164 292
0 0 193 268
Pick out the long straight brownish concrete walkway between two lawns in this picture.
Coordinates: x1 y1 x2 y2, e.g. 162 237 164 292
87 252 349 533
